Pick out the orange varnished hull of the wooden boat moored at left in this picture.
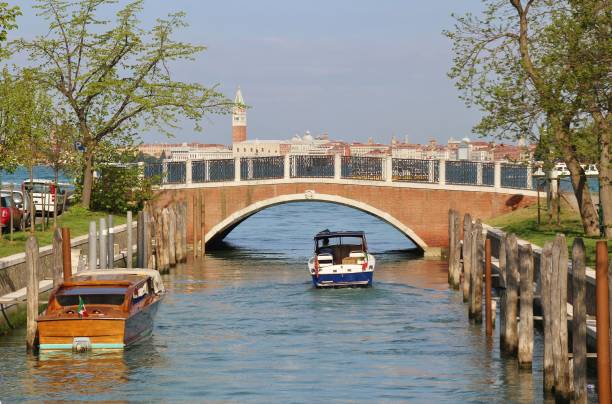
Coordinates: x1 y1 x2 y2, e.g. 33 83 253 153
38 299 161 350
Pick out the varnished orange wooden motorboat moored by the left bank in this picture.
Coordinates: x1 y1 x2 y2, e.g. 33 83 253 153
37 269 165 351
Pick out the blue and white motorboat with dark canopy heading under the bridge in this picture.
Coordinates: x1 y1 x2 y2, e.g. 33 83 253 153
308 230 376 288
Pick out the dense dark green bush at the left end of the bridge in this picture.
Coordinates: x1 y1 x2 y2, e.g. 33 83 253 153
91 165 153 213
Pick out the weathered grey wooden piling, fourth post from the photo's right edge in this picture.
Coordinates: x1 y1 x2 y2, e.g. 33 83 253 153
540 241 555 392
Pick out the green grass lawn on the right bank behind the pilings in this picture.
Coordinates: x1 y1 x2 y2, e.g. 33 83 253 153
486 201 612 268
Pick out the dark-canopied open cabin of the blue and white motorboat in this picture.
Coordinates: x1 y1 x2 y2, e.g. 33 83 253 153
314 230 368 267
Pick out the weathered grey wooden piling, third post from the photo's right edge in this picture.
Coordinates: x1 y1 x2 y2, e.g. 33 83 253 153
551 234 571 402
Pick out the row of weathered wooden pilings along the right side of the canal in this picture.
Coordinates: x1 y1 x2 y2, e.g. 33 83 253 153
448 209 612 403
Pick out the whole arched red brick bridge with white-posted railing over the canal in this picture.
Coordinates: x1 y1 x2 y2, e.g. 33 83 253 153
145 156 537 255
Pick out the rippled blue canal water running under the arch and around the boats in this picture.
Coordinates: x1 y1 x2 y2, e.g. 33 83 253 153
0 202 593 403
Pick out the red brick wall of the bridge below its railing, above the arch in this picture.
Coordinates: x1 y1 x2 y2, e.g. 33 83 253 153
153 183 536 247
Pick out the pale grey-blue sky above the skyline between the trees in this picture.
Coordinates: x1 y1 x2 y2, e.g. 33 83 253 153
11 0 481 144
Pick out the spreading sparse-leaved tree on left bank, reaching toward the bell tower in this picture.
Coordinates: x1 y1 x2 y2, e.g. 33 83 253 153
15 0 233 207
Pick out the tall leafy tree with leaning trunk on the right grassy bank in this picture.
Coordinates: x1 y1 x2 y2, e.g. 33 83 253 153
446 0 612 236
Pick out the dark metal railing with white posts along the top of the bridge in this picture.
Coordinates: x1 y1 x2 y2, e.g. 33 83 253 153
143 155 535 189
